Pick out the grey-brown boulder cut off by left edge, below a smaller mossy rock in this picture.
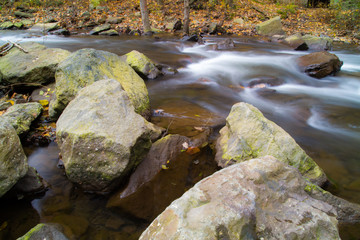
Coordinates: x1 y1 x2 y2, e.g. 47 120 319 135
0 117 28 197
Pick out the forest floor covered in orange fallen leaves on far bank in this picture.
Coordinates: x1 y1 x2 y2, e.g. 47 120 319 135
0 0 360 44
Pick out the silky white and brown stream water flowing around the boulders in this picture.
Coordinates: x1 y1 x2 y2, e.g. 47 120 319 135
0 31 360 239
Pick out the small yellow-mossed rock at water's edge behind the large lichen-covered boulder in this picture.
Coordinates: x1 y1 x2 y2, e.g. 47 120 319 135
124 50 161 79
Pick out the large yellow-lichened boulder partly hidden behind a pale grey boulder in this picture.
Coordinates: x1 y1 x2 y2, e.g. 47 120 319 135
49 49 150 119
